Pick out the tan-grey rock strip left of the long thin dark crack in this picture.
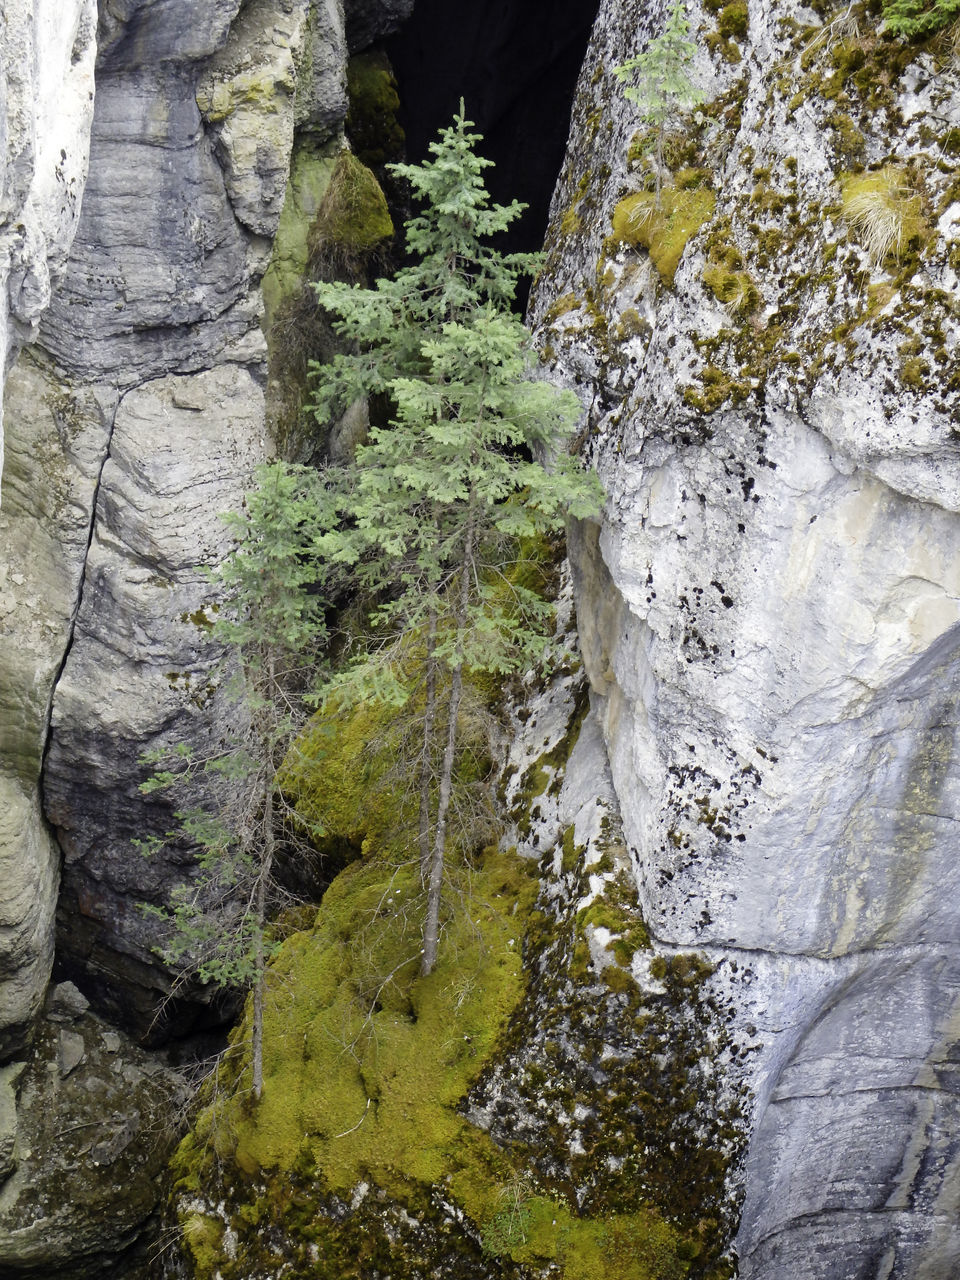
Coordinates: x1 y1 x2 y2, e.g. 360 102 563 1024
0 356 116 1057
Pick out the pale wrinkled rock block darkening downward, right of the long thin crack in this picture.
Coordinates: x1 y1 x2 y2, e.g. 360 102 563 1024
45 365 264 1032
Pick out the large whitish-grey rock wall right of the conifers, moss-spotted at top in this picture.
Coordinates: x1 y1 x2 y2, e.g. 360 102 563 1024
535 3 960 1280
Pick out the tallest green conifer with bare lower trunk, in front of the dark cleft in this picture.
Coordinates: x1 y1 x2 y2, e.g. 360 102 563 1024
315 104 600 974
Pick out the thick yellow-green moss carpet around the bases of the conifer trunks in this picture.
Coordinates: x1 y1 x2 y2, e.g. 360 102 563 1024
168 834 701 1280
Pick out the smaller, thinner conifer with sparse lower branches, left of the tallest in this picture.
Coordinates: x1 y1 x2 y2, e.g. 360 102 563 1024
141 463 335 1097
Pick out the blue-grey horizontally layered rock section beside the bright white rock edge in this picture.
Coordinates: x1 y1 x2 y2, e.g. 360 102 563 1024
42 61 256 387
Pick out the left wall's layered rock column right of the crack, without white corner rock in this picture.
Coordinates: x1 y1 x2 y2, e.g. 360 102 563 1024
34 0 358 1034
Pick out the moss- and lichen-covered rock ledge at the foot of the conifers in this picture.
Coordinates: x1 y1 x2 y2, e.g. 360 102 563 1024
163 655 735 1280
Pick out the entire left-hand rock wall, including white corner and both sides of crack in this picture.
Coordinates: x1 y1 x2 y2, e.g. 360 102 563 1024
0 0 371 1056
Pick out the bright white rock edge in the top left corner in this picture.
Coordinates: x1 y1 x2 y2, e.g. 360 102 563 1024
0 0 96 485
